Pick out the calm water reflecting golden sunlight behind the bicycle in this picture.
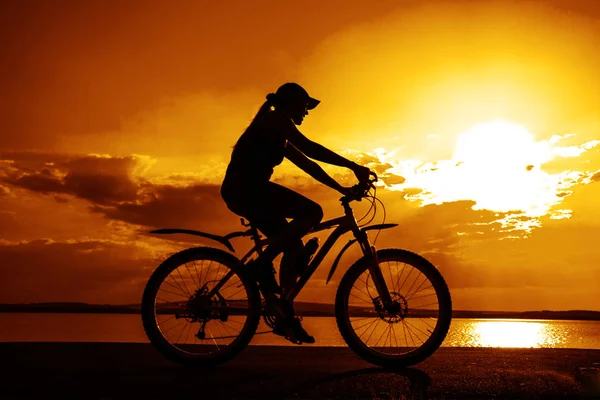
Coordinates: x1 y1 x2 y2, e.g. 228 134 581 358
0 313 600 349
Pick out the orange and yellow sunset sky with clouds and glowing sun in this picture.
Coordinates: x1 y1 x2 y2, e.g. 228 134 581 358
0 0 600 310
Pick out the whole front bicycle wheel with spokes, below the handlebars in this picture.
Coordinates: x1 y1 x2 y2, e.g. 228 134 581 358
335 249 452 367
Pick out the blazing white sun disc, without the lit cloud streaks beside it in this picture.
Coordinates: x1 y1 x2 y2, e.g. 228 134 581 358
439 121 556 216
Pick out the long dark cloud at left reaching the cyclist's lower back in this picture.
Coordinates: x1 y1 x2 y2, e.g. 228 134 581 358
0 154 245 239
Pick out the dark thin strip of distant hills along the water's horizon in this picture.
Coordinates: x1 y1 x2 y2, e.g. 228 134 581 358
0 302 600 321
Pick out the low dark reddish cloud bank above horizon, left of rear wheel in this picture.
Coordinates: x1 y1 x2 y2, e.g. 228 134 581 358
0 240 159 303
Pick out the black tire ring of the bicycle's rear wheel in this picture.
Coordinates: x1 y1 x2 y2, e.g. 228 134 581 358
141 247 261 367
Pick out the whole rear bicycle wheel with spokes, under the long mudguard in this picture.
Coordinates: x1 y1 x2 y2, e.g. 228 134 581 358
141 247 261 367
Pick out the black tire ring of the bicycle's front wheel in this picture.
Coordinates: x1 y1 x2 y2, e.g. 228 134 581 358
335 249 452 368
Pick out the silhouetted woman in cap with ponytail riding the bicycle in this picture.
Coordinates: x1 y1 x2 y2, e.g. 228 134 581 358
221 82 370 343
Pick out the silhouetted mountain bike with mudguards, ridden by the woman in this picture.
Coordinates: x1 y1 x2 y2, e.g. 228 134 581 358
141 174 452 367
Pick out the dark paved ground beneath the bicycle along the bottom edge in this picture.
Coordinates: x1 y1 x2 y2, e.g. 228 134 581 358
0 343 600 400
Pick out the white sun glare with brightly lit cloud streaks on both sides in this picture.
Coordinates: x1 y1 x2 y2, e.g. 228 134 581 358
374 120 600 232
